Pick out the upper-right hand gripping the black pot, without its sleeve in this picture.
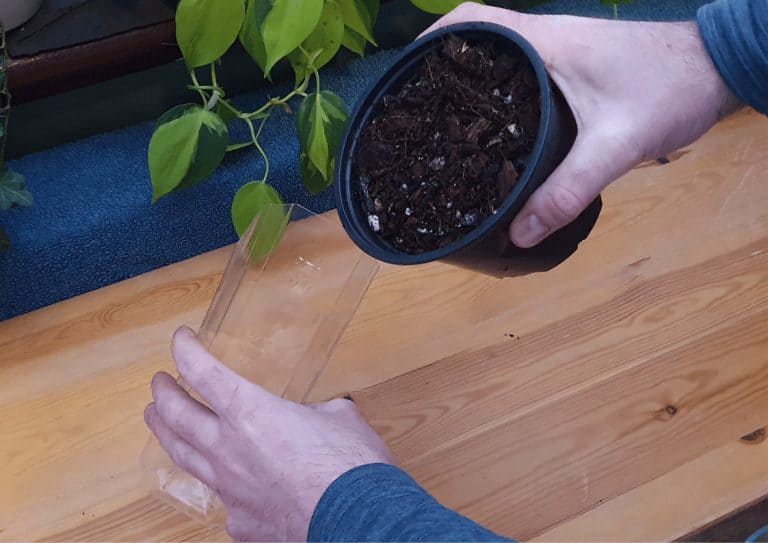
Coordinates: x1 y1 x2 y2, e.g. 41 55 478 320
426 3 739 248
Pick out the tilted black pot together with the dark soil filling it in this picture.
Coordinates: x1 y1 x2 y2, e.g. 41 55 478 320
335 23 601 275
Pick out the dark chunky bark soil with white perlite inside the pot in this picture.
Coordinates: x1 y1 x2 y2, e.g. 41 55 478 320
353 35 540 254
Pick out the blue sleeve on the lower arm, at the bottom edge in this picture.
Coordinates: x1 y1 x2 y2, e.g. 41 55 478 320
307 464 509 543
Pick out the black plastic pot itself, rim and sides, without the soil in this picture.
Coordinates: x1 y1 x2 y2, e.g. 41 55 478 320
334 23 602 277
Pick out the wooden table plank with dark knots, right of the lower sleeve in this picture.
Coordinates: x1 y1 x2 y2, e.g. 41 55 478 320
374 302 768 539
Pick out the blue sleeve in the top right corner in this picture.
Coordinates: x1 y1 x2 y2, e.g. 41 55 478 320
696 0 768 115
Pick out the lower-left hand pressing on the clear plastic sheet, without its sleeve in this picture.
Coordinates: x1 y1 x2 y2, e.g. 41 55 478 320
144 328 394 541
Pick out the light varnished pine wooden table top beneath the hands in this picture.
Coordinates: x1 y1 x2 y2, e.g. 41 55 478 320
0 112 768 541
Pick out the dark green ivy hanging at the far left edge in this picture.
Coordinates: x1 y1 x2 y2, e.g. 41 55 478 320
0 25 32 252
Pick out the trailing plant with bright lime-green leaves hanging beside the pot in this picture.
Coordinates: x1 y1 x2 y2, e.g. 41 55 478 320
147 0 629 235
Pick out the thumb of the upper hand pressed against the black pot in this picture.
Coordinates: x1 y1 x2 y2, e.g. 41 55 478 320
509 131 636 248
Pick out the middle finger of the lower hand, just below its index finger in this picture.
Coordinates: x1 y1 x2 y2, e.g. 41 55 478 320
152 372 219 451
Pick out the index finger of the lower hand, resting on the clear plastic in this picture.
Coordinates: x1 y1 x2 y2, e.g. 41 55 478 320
171 327 279 418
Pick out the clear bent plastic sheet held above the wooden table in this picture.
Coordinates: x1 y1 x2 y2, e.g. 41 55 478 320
142 204 379 524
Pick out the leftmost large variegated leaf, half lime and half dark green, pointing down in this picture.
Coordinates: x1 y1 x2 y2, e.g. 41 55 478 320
148 104 227 202
